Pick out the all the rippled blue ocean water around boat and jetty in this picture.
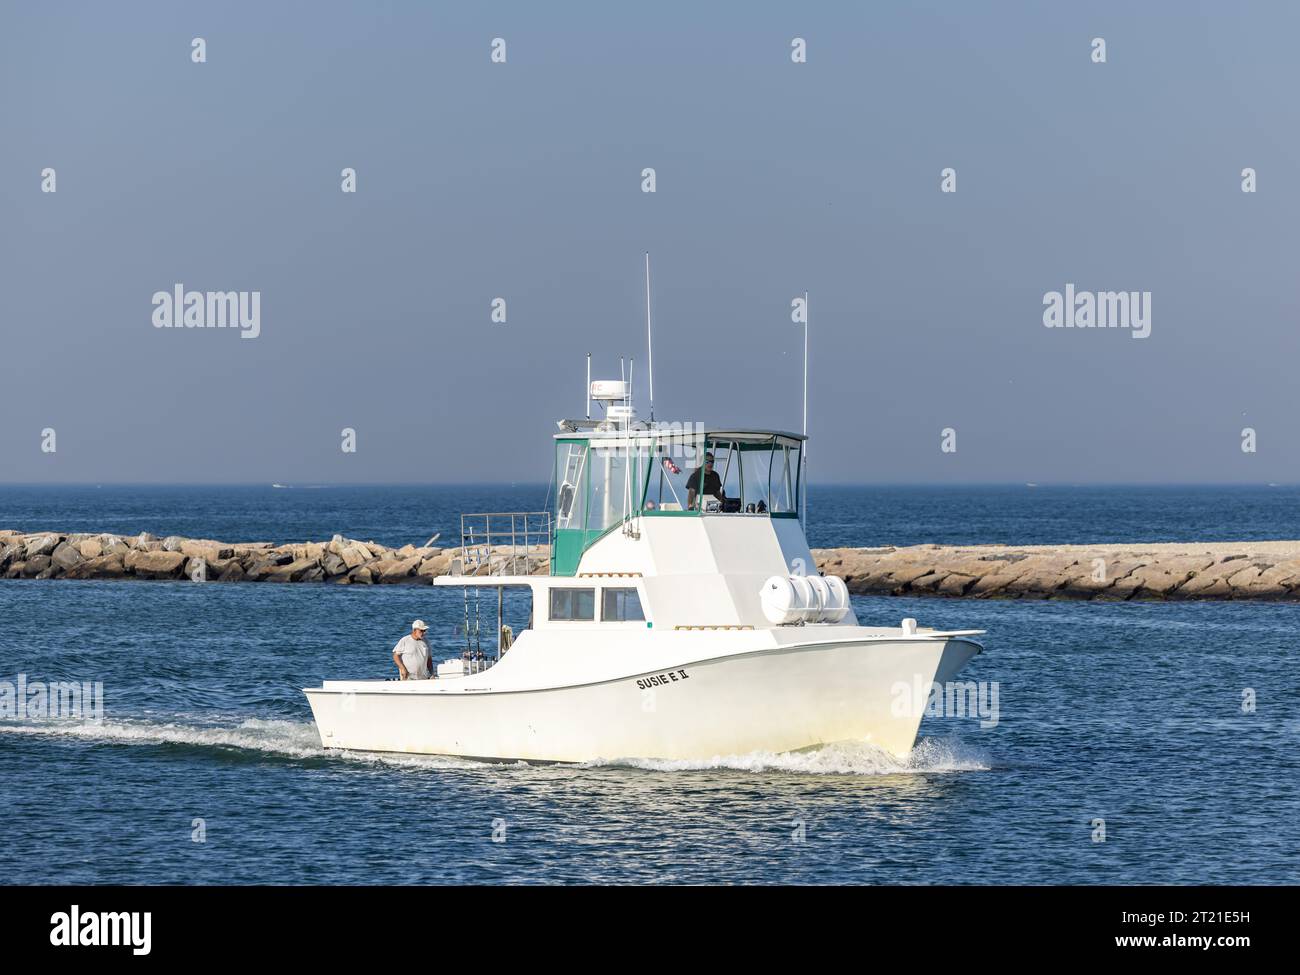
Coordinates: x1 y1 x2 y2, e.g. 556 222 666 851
0 486 1300 884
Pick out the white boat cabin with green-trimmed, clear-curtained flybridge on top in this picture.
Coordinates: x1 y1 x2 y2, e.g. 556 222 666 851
436 420 816 650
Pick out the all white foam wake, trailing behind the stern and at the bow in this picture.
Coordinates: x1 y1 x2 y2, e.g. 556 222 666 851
0 718 992 775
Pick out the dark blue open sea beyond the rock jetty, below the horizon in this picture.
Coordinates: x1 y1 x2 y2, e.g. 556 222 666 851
0 484 1300 547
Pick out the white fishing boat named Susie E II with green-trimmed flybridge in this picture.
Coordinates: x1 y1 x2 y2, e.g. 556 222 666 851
304 256 983 762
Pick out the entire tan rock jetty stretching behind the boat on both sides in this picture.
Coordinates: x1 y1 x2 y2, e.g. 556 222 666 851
0 529 1300 601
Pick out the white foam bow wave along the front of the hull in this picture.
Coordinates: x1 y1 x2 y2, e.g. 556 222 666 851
593 738 992 775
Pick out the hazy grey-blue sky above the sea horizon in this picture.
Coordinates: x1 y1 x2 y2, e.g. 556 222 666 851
0 0 1300 482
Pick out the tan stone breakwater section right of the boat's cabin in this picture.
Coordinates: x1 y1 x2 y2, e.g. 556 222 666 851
815 541 1300 599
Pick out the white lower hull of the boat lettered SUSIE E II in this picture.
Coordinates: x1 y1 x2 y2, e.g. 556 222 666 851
304 636 980 762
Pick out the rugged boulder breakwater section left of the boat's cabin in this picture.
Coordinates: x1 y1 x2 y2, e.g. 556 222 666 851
0 529 549 585
